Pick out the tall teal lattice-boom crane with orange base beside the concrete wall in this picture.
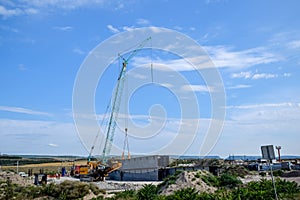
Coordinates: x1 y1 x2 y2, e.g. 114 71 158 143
74 37 152 180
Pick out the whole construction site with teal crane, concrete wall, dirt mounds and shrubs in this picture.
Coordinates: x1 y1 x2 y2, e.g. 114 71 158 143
0 37 300 199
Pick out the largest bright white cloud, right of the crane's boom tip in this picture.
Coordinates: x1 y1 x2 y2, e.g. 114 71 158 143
204 46 281 68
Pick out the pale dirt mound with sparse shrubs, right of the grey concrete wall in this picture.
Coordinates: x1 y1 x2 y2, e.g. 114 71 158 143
161 170 217 195
